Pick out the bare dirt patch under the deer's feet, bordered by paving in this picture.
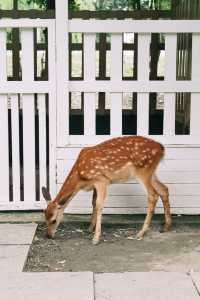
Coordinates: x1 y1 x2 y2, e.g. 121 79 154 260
24 222 200 273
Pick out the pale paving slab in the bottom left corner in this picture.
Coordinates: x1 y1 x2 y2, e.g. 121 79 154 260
0 272 94 300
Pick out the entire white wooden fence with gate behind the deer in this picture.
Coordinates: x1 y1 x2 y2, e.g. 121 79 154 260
0 0 200 214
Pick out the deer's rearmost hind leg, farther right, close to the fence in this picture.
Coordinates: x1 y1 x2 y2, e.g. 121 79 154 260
152 174 172 231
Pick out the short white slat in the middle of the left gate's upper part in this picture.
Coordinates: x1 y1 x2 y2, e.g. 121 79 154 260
21 29 34 83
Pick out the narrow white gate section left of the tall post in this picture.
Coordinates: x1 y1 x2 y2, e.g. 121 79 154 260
0 19 56 210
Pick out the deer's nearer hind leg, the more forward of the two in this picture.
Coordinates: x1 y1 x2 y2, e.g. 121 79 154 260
137 178 158 239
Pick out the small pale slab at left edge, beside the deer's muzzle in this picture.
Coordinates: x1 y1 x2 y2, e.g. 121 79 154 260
0 223 37 245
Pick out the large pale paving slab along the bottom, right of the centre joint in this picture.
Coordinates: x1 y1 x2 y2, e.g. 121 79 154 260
95 272 199 300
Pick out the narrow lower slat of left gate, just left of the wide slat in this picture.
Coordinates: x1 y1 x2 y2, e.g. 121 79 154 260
10 94 20 202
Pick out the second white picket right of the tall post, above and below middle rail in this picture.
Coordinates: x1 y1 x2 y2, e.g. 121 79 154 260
110 33 123 136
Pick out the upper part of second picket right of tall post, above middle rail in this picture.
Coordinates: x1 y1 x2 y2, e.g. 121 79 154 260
111 34 122 82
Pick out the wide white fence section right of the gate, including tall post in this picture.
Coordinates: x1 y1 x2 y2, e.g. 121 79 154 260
56 1 200 214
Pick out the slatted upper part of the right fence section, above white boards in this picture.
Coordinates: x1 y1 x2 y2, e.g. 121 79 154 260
55 20 200 146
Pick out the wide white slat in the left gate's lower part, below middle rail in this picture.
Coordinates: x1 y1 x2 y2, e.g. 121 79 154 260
23 94 36 203
